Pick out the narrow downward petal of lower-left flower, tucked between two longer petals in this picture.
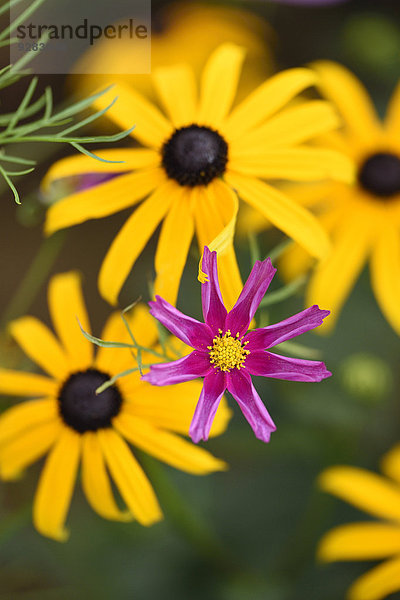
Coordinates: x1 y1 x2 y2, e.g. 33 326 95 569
82 432 133 521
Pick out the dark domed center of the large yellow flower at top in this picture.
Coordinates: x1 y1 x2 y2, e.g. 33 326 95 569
162 125 228 187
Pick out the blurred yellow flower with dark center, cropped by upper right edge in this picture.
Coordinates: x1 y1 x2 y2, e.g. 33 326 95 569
281 62 400 333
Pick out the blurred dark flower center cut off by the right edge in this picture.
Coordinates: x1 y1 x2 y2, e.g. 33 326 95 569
358 152 400 198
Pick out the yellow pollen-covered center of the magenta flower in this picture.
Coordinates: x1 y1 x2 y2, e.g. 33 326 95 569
207 329 250 371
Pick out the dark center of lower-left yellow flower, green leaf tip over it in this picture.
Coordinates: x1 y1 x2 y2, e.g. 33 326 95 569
58 369 122 433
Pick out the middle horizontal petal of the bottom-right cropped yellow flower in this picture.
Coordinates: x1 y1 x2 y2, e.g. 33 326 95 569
318 523 400 562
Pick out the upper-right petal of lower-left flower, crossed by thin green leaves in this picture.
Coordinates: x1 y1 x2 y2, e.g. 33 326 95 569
96 304 158 375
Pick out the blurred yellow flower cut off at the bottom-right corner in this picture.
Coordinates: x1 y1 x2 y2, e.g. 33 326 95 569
318 444 400 600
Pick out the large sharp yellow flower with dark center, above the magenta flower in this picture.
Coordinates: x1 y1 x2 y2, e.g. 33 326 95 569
44 44 352 308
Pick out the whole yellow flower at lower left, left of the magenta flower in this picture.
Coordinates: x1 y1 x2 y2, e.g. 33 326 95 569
0 272 230 541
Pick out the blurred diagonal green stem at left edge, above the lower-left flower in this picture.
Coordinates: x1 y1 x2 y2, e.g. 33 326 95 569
0 231 67 329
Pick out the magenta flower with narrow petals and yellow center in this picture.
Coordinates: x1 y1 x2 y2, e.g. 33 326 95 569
143 247 331 442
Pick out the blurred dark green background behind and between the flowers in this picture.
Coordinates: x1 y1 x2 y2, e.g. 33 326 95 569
0 0 400 600
